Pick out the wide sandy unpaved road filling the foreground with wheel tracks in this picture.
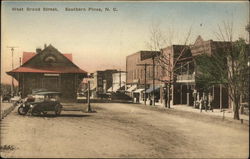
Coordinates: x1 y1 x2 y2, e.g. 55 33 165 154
1 103 249 158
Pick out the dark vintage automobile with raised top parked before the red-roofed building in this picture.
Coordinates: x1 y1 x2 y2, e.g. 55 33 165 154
18 91 62 115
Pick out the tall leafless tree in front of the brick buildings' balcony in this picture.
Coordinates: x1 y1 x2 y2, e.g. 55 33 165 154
147 23 192 108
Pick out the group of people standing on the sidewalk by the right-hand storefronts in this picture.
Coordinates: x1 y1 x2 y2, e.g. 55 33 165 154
193 90 213 112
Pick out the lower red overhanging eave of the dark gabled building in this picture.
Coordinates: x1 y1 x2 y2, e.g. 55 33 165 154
7 66 87 74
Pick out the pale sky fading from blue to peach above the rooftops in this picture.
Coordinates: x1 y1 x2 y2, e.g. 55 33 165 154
1 1 249 83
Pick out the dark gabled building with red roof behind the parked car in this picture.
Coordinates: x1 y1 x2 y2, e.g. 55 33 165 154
7 45 87 100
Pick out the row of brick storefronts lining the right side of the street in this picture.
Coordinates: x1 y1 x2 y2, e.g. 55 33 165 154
126 36 230 108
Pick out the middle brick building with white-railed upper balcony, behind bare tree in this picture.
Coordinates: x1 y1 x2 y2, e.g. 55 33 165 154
162 45 194 104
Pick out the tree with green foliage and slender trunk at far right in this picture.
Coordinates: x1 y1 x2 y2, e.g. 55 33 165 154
195 38 249 120
